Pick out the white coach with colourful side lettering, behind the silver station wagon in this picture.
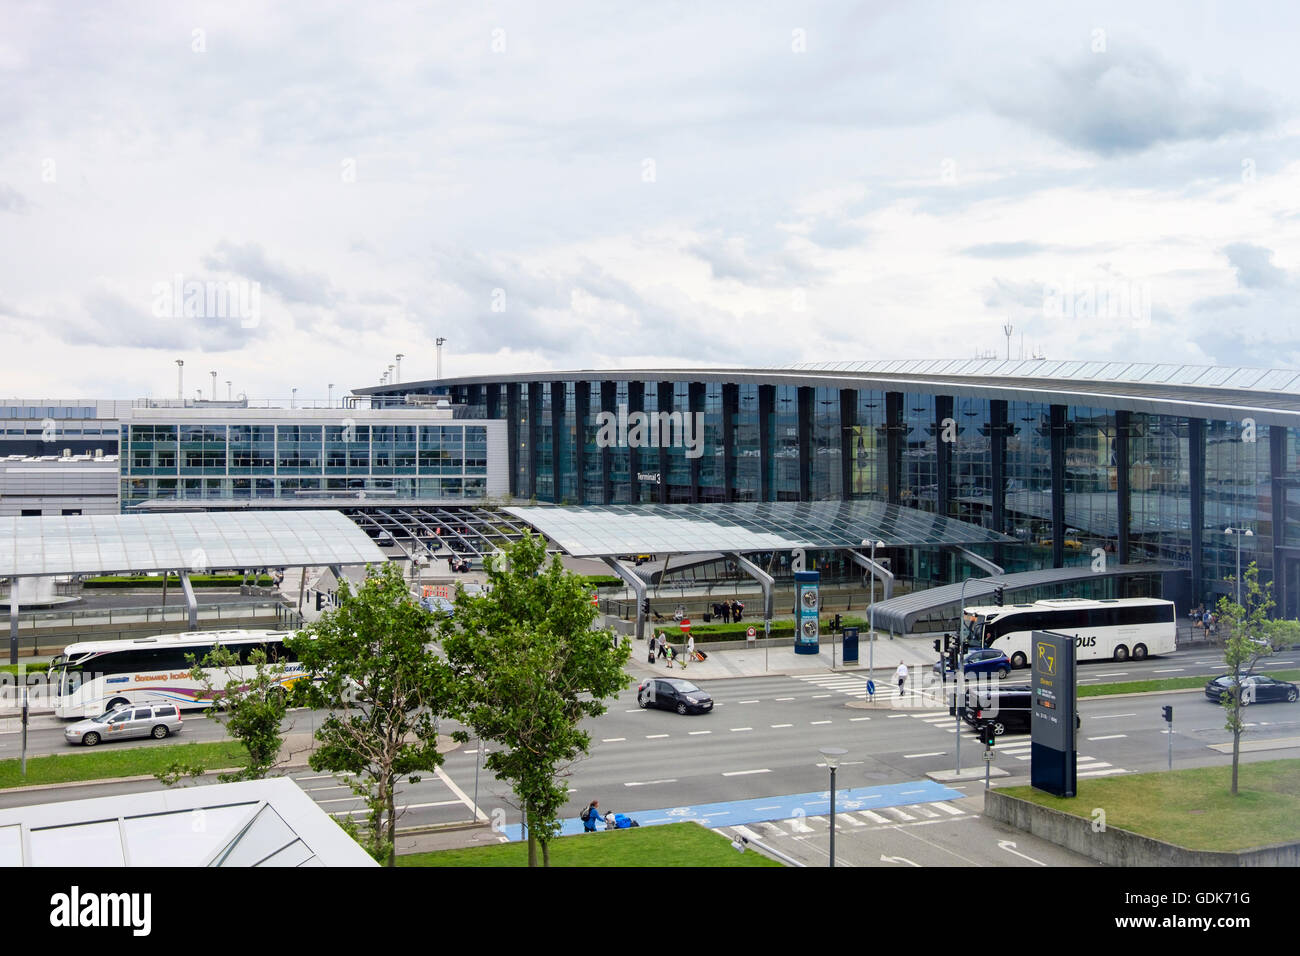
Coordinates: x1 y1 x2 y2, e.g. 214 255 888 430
48 631 303 718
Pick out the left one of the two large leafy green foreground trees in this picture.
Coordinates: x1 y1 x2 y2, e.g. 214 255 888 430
286 563 455 866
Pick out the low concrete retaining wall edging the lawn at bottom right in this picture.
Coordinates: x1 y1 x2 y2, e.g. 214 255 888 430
984 790 1300 866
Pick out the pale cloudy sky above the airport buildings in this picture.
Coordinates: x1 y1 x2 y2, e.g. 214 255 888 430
0 0 1300 399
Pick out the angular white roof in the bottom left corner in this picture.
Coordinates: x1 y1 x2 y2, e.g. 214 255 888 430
0 777 378 868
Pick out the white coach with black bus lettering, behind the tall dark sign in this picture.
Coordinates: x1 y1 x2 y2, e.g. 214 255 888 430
962 597 1178 667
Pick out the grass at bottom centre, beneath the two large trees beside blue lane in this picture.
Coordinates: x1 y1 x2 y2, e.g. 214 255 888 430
398 823 781 866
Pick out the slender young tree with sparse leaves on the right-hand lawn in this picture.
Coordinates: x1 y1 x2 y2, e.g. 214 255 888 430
1216 561 1300 796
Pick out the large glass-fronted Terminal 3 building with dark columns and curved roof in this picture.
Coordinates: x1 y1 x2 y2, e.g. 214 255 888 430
354 359 1300 617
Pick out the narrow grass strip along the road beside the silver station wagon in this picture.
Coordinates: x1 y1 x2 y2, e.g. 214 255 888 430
0 740 248 788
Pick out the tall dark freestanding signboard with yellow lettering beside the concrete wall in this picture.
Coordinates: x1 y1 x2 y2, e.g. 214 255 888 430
1028 631 1078 797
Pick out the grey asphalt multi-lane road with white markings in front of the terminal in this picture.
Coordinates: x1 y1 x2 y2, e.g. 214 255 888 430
0 652 1300 866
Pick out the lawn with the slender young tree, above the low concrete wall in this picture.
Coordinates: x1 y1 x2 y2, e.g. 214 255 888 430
1001 758 1300 851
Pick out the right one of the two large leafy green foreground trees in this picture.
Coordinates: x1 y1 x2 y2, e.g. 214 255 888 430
439 535 629 866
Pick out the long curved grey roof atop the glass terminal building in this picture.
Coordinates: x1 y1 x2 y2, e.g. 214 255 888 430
355 359 1300 425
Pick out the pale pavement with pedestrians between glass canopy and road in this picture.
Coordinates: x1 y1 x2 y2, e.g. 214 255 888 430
627 632 937 683
